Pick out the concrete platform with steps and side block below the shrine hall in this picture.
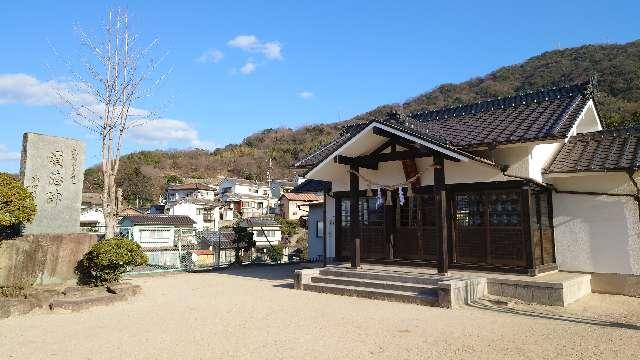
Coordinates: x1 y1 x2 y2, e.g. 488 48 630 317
295 264 591 307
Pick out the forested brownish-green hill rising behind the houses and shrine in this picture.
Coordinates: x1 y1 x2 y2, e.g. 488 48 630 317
85 40 640 201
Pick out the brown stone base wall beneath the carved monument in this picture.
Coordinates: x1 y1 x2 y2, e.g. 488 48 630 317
0 234 98 287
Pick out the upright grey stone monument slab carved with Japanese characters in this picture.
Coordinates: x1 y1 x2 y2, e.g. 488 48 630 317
20 133 84 234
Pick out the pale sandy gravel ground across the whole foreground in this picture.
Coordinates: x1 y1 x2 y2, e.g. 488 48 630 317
0 267 640 360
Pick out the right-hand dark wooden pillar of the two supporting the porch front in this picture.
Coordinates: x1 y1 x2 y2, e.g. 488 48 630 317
433 155 449 274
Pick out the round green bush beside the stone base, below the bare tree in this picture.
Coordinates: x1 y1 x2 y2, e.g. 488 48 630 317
76 237 148 286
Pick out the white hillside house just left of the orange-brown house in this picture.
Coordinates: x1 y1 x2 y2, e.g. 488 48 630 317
219 178 273 218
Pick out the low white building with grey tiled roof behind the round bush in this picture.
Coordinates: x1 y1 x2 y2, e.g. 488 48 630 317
118 214 195 248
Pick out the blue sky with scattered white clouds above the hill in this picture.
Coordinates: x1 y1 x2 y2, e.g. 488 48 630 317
0 0 640 172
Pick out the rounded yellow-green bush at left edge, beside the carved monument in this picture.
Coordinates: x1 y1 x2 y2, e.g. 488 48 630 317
0 173 36 238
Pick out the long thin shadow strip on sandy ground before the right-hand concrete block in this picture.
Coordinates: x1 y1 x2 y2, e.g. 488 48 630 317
469 301 640 330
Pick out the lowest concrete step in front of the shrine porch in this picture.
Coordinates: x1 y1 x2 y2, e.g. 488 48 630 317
304 283 440 306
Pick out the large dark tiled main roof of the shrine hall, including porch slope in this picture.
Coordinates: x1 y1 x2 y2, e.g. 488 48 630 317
296 83 592 167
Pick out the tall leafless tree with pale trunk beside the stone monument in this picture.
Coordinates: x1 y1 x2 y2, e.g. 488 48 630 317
58 9 166 238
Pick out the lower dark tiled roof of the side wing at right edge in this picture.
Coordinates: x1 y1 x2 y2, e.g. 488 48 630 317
546 126 640 173
